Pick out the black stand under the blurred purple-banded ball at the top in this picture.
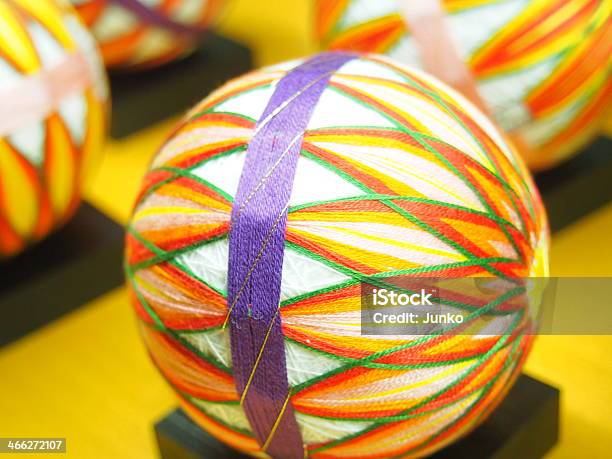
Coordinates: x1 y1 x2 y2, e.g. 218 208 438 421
110 32 252 139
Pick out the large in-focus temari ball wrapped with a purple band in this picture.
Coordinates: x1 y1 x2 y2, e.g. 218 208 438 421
126 53 548 458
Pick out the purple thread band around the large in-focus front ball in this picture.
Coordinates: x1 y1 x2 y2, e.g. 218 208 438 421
228 53 356 459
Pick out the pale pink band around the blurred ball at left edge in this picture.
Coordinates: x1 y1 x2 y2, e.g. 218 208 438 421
0 52 94 137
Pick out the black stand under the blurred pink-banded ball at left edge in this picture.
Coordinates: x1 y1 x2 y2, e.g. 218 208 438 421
0 204 123 345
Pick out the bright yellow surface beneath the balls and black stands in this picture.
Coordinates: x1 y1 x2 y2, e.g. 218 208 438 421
0 0 612 459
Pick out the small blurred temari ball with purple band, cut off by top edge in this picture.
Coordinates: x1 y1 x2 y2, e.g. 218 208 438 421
71 0 223 69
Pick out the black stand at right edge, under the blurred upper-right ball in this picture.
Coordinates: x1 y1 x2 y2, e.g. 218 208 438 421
536 137 612 231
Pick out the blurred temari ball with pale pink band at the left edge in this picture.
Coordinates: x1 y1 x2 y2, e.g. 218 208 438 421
0 0 107 258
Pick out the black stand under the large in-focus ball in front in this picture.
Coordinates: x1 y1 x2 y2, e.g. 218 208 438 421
155 375 559 459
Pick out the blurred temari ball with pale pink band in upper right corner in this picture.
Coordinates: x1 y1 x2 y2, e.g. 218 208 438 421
316 0 612 170
